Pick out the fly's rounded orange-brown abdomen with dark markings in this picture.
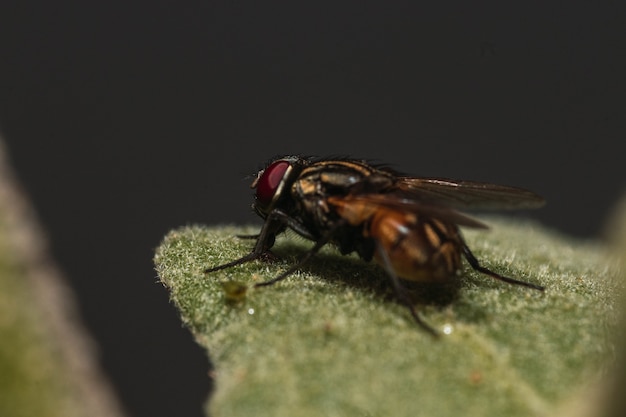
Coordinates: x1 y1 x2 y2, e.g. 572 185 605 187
369 209 461 282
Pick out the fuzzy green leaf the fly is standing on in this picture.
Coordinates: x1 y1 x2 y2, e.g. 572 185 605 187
155 218 621 417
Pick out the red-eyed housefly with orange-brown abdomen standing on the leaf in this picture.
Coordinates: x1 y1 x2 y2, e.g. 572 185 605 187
205 156 544 334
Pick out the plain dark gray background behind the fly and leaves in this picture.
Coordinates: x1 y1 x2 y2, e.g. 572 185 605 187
0 0 626 416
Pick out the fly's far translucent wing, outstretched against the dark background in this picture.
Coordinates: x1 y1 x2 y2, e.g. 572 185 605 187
392 176 545 210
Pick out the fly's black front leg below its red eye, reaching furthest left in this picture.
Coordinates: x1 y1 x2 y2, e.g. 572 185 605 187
204 210 308 274
